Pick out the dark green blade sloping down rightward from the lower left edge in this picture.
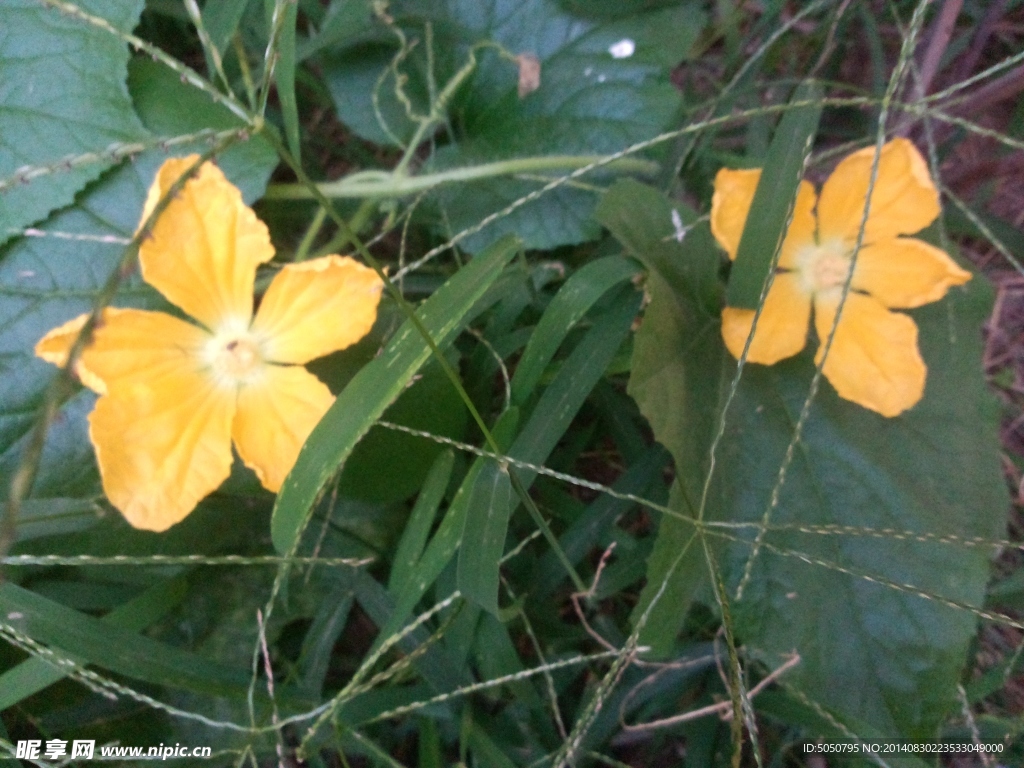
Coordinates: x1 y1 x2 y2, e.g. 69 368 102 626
0 584 249 696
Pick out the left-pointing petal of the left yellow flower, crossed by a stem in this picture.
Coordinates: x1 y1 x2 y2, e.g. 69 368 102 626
36 307 209 394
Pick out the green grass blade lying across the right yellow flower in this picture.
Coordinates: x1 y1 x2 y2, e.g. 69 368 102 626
725 82 822 309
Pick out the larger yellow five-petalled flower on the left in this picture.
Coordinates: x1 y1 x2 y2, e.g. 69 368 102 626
36 156 382 530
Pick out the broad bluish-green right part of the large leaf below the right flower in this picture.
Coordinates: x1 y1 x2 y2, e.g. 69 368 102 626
713 278 1007 738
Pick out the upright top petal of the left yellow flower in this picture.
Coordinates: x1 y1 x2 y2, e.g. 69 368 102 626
139 155 273 331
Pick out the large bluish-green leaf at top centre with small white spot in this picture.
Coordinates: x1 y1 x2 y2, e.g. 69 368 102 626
325 0 706 251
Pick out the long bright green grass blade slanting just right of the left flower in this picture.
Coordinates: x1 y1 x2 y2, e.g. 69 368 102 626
270 238 519 553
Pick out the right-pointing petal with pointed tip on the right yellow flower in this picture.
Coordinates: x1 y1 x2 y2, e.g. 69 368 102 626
853 238 971 309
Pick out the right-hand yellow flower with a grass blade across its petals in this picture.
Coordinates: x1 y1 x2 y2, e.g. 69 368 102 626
711 138 971 417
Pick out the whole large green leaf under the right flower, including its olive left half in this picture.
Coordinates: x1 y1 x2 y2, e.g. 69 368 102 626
601 182 1006 738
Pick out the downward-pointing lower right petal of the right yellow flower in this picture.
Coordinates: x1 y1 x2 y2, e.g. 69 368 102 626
814 293 928 417
